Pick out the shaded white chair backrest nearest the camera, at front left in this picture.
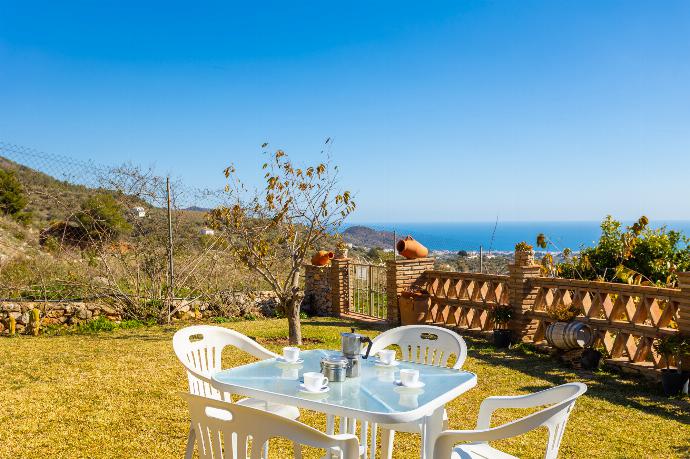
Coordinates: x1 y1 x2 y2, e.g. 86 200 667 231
183 394 359 459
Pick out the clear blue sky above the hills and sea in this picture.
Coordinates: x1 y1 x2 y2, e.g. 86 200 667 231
0 1 690 222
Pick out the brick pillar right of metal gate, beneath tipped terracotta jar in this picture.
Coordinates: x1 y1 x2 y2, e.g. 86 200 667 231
386 258 435 326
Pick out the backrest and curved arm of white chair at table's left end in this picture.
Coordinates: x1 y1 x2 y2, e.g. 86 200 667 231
173 325 277 399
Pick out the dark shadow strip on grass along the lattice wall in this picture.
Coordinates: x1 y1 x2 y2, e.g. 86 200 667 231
464 336 690 424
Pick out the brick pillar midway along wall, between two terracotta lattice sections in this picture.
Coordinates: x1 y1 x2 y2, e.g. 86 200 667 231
508 250 541 342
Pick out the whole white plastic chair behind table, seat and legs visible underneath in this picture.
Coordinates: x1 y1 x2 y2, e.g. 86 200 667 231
327 325 467 459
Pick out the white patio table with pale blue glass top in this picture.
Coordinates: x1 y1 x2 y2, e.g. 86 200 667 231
212 350 477 459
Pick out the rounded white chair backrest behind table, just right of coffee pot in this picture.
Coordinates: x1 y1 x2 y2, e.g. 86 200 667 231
371 325 467 370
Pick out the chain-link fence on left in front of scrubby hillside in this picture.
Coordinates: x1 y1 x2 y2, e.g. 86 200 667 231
0 142 261 317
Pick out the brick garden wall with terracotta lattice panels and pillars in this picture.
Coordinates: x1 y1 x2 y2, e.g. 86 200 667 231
305 251 690 378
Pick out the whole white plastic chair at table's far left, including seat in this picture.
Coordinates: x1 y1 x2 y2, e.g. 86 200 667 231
173 325 299 459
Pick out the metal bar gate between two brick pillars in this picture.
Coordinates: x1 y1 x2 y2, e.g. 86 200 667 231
348 263 387 319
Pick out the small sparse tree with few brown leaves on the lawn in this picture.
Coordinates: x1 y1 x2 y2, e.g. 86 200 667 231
209 144 355 344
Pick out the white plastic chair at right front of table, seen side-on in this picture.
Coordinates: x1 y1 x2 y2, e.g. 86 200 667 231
434 383 587 459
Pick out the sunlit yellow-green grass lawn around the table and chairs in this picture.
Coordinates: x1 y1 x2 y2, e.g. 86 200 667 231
0 319 690 459
